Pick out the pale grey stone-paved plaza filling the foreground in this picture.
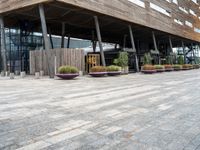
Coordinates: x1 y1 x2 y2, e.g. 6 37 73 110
0 70 200 150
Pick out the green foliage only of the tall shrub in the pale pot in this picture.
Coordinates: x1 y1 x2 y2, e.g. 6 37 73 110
113 52 128 67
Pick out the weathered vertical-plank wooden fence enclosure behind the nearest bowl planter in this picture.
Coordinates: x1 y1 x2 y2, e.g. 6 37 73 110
29 49 85 75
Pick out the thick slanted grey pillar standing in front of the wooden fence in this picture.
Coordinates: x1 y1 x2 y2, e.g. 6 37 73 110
39 4 54 78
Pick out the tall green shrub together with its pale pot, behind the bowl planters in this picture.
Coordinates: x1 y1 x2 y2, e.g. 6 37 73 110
114 52 129 74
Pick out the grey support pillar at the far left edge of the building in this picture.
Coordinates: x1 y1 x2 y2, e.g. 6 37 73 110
0 16 7 72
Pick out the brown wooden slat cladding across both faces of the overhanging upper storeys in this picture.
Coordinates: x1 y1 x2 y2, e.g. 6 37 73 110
0 0 200 42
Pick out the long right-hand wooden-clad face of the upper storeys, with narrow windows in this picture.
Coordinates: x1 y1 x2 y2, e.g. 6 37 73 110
57 0 200 42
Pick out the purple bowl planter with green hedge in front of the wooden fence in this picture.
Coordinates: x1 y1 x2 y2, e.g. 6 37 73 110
56 66 79 80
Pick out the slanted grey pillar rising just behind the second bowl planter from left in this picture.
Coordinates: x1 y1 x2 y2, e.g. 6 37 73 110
94 16 106 66
